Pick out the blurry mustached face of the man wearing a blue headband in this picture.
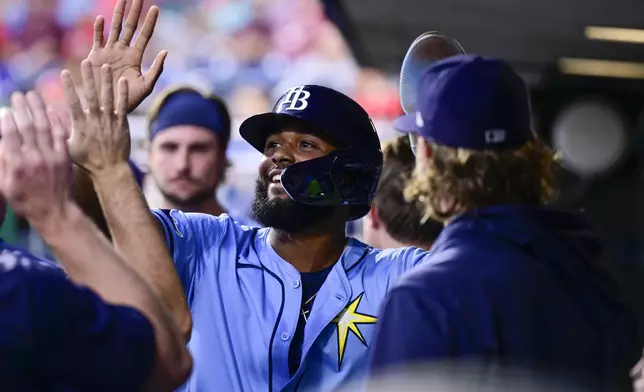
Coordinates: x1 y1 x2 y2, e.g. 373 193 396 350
149 125 226 206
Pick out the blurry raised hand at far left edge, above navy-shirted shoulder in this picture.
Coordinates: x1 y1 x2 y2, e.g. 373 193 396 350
0 92 72 230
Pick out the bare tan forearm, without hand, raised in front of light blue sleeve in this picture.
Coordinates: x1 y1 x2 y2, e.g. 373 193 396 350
93 163 192 337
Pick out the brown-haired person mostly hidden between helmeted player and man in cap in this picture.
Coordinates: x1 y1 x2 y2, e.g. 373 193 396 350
362 136 443 250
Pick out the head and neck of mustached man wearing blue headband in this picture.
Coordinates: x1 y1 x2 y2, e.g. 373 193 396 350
148 86 235 215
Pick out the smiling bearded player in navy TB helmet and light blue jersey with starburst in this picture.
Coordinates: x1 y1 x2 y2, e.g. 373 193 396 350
63 39 468 391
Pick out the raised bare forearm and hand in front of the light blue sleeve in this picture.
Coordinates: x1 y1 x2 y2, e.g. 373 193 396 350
62 61 192 341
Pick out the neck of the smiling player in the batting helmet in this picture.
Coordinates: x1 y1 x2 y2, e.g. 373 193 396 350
268 224 347 272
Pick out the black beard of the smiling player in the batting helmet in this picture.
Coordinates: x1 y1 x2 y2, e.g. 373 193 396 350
251 178 335 233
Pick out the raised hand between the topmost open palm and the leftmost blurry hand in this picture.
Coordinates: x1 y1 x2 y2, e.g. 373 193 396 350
61 60 131 176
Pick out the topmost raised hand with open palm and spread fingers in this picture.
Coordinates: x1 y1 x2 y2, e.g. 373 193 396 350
87 0 167 113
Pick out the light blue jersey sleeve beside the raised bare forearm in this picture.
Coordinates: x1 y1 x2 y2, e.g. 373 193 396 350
152 209 231 304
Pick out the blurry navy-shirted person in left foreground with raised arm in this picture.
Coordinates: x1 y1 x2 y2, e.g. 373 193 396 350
0 87 192 392
